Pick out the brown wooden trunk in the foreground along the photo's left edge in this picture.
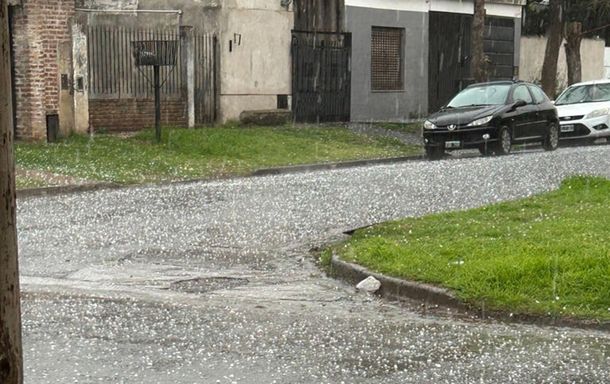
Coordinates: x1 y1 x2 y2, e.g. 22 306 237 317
0 0 23 384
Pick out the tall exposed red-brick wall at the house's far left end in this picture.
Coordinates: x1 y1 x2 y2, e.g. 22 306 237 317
12 0 74 139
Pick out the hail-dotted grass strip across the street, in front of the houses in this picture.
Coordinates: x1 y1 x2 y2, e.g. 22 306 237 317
15 126 420 184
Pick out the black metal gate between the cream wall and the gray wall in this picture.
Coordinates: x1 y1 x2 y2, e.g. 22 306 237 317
292 31 352 123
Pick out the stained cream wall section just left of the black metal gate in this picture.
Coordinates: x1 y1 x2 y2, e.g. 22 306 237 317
219 0 294 121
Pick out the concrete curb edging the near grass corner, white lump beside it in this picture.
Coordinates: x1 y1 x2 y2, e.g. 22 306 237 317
330 255 610 332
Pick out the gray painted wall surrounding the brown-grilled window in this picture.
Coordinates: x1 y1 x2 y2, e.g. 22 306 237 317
346 6 428 121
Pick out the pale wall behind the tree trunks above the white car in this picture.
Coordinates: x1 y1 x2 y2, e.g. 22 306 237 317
519 36 605 91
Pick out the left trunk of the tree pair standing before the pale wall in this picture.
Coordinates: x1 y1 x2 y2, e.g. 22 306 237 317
540 0 562 99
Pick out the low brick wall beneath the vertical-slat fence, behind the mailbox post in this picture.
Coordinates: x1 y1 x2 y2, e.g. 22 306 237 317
89 99 188 132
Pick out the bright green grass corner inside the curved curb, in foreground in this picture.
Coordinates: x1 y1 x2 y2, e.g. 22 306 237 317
333 177 610 320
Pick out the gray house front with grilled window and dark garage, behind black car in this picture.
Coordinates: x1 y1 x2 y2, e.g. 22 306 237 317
345 0 525 121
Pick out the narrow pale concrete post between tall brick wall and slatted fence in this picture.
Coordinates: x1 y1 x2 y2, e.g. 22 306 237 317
72 19 89 133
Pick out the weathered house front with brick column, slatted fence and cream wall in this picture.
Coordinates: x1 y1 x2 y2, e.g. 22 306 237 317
10 0 294 140
